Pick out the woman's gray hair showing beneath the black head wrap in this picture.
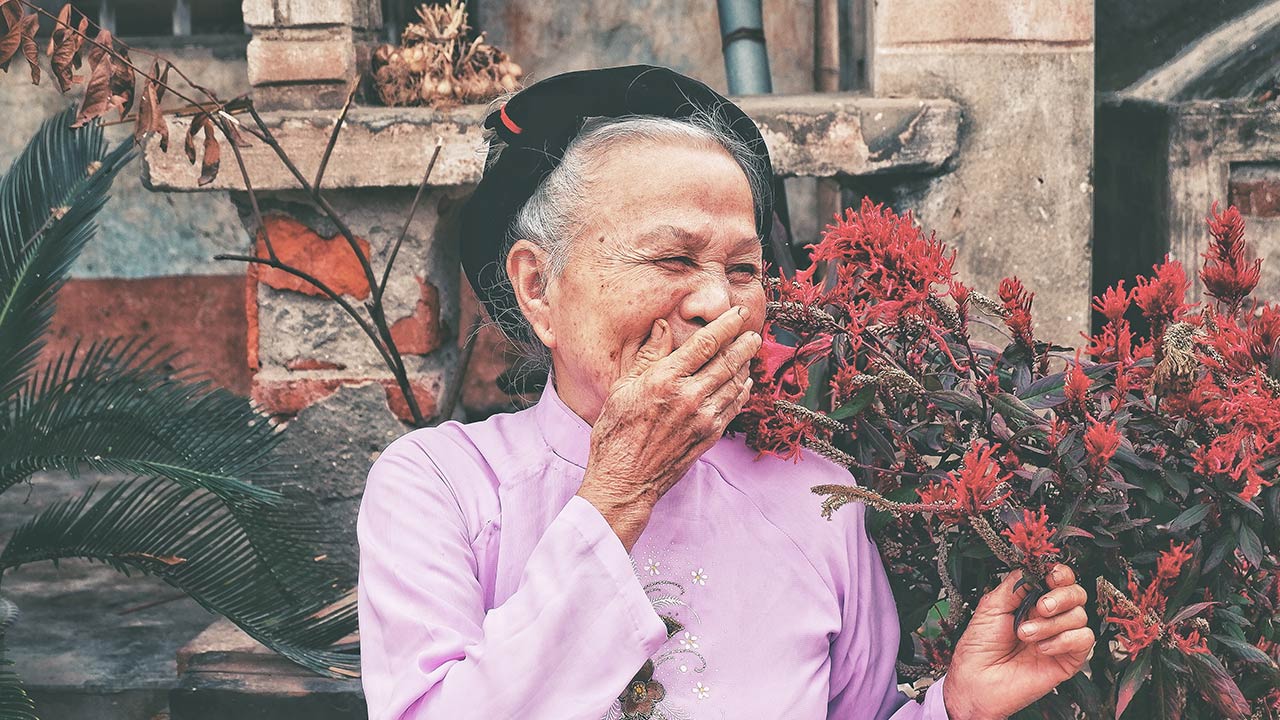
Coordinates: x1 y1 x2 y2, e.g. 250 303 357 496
490 113 772 370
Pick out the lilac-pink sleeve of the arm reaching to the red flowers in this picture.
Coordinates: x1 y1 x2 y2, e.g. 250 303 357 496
827 497 947 720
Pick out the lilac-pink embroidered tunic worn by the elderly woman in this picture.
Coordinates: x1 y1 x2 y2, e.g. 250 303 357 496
358 383 946 720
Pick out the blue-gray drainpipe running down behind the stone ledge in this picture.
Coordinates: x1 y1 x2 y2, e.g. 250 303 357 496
716 0 796 277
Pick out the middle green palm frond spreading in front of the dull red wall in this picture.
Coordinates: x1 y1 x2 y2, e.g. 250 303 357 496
0 340 280 505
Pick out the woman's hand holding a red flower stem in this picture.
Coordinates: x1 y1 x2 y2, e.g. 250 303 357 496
943 565 1094 720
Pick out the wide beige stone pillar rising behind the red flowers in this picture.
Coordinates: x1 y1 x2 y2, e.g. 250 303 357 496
868 0 1093 345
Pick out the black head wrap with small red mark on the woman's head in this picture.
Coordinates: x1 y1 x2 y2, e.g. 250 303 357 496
462 65 773 342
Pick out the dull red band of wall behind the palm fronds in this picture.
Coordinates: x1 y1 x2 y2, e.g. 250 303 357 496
41 275 250 395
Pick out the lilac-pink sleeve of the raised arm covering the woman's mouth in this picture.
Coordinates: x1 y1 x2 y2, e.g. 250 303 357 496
357 433 667 720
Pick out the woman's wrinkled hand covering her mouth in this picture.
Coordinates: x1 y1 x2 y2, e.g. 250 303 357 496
577 306 762 552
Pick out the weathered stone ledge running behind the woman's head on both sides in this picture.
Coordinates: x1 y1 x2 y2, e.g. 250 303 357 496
143 95 961 191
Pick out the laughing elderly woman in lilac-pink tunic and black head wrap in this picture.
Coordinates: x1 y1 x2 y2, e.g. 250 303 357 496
358 67 1093 720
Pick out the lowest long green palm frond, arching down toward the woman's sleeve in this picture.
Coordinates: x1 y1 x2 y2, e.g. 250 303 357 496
0 478 358 676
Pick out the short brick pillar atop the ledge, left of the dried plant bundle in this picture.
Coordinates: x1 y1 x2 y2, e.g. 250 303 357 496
243 0 383 110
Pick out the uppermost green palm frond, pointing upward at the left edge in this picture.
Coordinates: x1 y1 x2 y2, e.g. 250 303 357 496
0 109 132 398
